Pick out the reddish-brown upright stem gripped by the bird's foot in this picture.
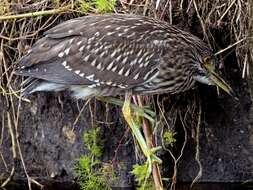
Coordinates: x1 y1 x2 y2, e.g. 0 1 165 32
137 96 163 190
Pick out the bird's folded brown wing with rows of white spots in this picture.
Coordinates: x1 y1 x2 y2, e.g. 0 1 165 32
16 15 170 88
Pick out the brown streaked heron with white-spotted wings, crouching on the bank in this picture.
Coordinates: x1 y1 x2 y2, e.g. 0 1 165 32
15 15 233 175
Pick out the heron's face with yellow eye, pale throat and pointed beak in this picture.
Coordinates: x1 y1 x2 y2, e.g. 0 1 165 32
193 55 234 95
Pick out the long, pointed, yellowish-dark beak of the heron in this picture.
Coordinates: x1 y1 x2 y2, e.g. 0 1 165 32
205 65 235 96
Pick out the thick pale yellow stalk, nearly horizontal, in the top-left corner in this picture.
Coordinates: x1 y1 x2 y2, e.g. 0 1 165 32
0 6 70 21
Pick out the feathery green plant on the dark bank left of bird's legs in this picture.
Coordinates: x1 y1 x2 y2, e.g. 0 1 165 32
74 127 115 190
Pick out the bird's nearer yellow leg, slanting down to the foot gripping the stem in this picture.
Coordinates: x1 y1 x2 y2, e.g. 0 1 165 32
122 93 161 171
